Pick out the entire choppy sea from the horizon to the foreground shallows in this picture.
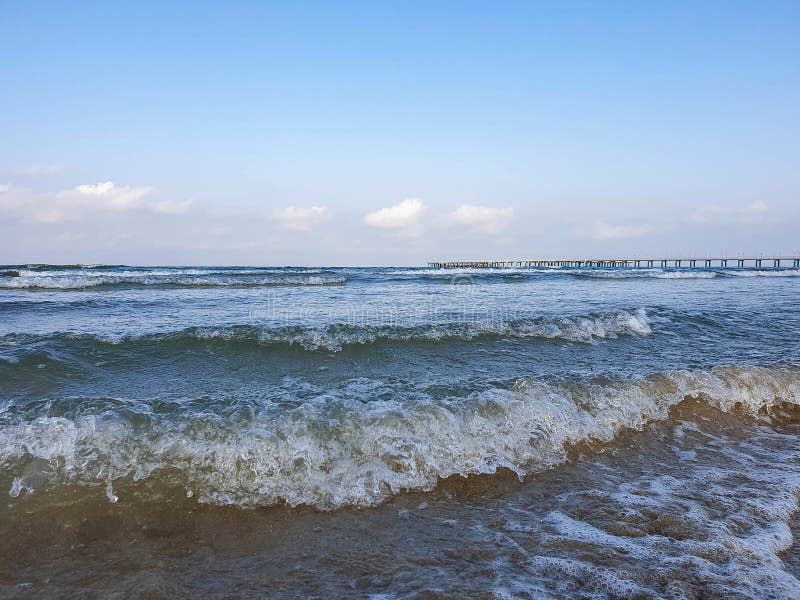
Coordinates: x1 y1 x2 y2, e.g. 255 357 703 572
0 264 800 600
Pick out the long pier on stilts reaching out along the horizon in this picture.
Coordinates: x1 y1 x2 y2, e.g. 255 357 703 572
428 256 800 269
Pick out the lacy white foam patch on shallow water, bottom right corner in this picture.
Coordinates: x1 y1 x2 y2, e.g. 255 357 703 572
495 428 800 599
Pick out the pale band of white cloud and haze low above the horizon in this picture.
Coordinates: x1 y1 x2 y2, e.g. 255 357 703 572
0 180 797 264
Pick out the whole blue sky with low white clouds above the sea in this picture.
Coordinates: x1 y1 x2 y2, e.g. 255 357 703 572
0 0 800 265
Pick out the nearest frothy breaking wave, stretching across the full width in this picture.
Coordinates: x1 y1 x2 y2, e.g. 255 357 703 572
0 366 800 509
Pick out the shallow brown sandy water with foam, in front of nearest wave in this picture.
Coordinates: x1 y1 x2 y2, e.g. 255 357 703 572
0 400 800 598
